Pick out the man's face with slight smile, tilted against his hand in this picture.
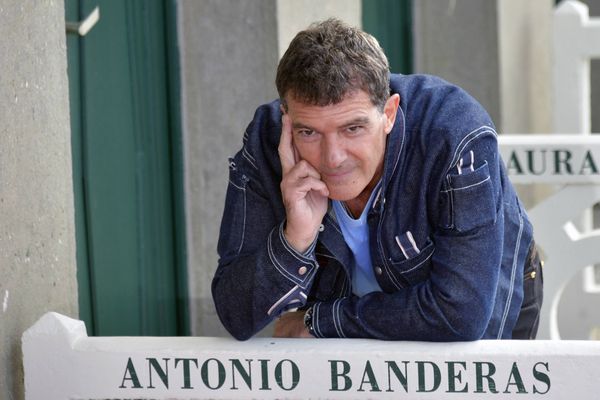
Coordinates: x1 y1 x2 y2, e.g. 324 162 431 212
286 90 399 201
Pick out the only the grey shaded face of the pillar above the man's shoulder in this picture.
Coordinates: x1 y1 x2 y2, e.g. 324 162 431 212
413 0 501 128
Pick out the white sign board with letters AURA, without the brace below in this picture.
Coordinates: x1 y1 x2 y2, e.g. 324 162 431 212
498 134 600 184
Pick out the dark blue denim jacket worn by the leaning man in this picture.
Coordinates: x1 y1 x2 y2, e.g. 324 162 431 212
212 75 532 341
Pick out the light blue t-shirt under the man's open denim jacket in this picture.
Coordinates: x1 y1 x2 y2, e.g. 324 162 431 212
332 182 381 297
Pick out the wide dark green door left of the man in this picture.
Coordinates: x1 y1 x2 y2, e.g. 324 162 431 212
65 0 187 335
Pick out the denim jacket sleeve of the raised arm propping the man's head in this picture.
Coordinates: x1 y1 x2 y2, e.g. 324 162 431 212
212 136 318 340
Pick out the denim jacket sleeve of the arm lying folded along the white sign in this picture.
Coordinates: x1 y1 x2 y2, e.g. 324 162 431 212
304 128 504 341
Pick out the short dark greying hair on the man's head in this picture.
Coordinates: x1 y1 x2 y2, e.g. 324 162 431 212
275 19 390 110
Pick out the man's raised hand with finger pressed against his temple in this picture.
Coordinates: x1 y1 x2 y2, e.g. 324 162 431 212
278 114 329 253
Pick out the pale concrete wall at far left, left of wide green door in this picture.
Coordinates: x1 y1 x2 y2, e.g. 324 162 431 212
0 0 77 400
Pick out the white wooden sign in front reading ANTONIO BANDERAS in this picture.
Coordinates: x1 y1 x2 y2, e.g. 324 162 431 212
23 313 600 400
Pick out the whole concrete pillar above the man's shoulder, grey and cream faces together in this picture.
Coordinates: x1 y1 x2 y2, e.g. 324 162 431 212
414 0 554 133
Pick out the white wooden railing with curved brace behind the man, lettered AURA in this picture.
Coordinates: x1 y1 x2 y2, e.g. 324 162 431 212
499 135 600 339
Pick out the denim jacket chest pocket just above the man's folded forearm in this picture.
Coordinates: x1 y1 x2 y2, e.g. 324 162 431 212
389 238 435 288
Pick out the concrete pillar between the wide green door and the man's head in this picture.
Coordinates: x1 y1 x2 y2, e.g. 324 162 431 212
178 0 360 336
